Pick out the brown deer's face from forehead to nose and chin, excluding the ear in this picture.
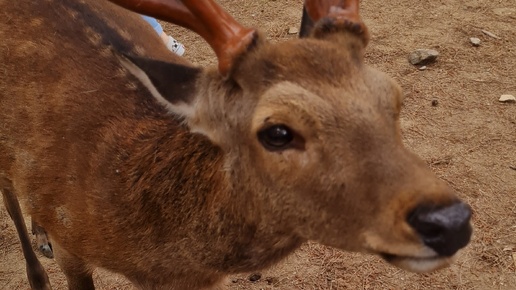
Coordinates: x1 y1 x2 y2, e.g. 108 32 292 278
232 34 470 271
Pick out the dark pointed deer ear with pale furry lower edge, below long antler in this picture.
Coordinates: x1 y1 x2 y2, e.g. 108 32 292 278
117 54 201 118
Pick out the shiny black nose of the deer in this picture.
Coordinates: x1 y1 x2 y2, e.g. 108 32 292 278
408 202 472 256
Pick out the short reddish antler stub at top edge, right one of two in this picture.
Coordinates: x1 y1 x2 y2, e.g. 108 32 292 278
305 0 369 44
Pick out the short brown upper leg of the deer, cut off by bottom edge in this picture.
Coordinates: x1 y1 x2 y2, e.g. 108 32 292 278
52 241 95 290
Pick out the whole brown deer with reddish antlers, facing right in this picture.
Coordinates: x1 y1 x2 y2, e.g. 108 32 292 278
0 0 472 289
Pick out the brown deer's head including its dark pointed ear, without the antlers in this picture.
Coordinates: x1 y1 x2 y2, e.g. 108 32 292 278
118 0 471 272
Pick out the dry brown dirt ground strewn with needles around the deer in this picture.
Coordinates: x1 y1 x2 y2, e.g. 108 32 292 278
0 0 516 290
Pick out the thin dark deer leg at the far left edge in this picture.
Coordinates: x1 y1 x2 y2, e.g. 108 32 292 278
0 180 52 290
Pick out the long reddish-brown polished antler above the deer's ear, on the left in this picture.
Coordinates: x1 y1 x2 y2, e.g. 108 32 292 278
109 0 256 76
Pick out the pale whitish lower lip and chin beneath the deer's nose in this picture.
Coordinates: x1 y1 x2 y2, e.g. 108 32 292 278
380 253 454 273
